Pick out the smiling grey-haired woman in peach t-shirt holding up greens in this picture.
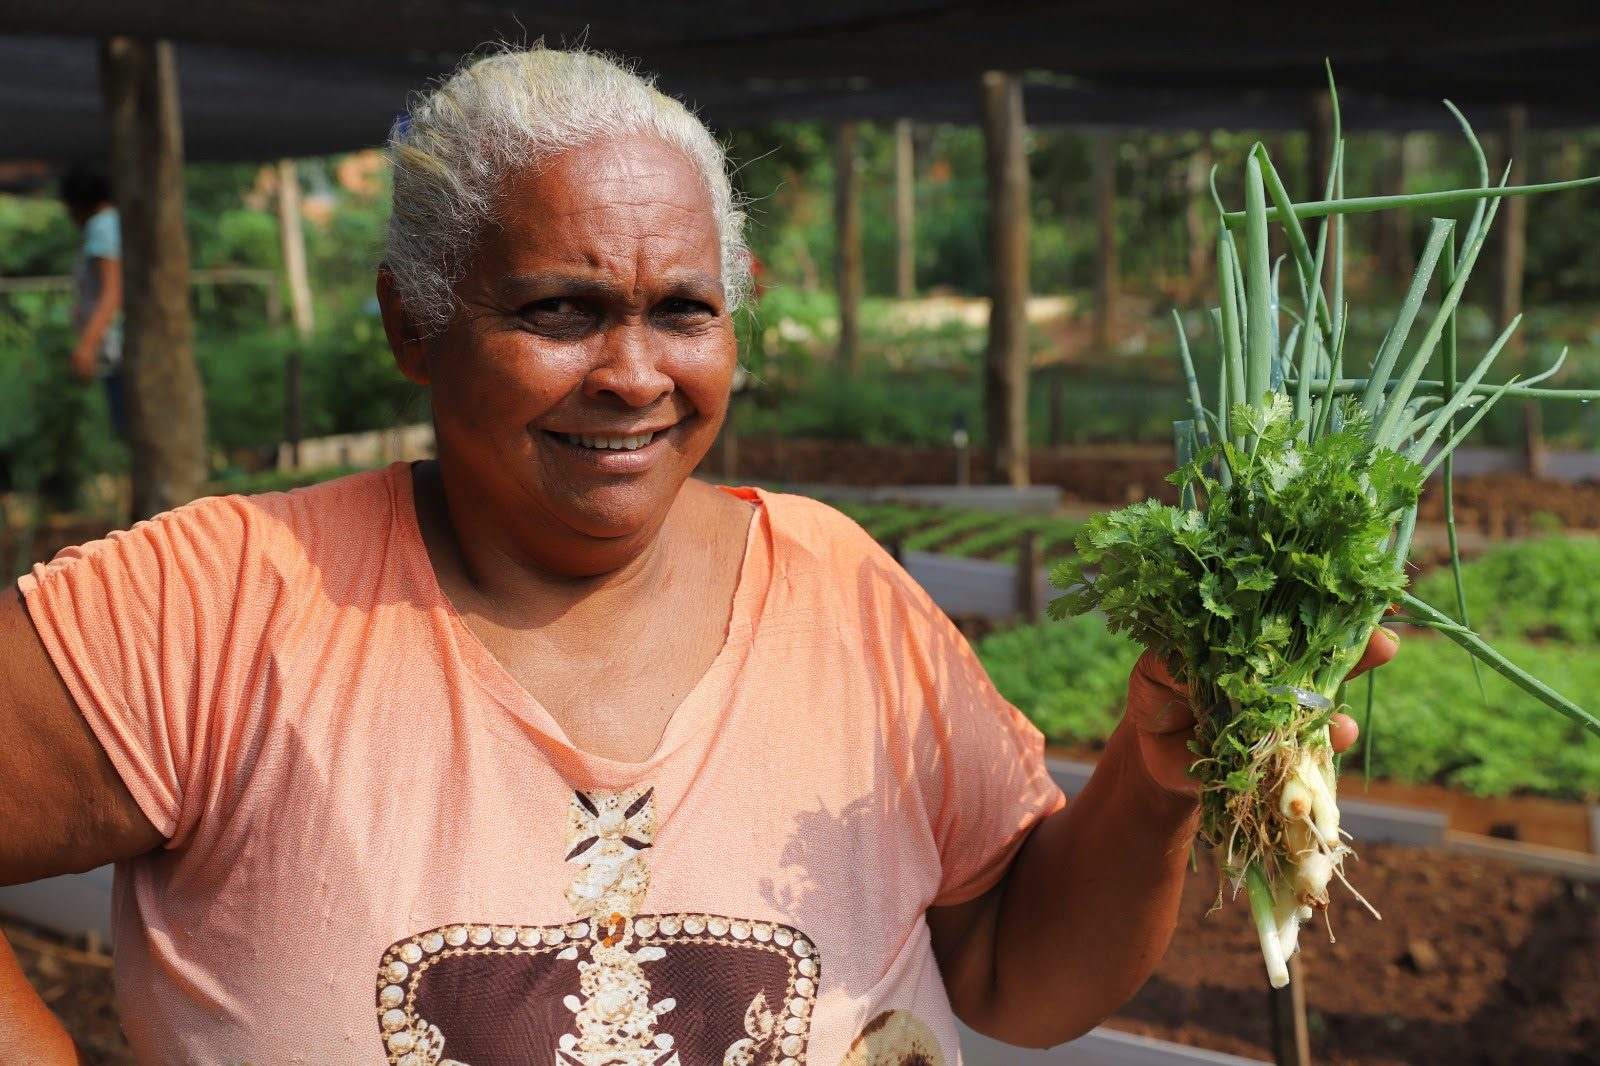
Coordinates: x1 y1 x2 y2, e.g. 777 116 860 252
0 48 1387 1066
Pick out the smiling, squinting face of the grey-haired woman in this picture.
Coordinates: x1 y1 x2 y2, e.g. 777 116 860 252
397 139 738 550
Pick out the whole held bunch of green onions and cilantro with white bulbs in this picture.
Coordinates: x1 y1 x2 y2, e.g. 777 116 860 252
1050 76 1600 988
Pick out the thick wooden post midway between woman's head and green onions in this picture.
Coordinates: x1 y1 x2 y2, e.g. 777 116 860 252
982 70 1027 485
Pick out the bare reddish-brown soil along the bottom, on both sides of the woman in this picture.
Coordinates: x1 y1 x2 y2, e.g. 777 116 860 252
6 845 1600 1066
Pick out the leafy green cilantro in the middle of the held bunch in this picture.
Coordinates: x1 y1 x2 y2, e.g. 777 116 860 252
1050 397 1422 707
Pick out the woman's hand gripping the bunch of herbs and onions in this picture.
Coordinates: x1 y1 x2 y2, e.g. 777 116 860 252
1126 626 1400 797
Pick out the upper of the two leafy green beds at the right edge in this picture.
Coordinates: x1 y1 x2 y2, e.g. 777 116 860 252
1416 536 1600 640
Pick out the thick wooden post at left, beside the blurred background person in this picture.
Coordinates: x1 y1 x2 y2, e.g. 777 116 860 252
101 37 206 520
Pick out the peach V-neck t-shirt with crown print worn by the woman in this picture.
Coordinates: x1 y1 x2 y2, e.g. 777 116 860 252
22 464 1062 1066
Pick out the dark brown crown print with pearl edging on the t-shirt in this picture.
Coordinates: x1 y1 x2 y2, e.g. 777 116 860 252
378 789 821 1066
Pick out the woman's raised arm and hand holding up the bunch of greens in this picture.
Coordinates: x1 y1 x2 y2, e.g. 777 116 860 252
928 634 1395 1047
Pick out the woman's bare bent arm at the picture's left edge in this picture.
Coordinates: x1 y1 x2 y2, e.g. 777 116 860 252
0 587 162 1066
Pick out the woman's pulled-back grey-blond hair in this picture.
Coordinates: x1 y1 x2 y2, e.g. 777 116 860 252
387 45 750 333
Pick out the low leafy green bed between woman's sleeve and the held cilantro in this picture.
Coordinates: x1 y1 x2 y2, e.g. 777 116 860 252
976 616 1139 747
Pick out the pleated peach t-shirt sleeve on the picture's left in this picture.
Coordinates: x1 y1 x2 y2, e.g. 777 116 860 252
18 498 248 842
